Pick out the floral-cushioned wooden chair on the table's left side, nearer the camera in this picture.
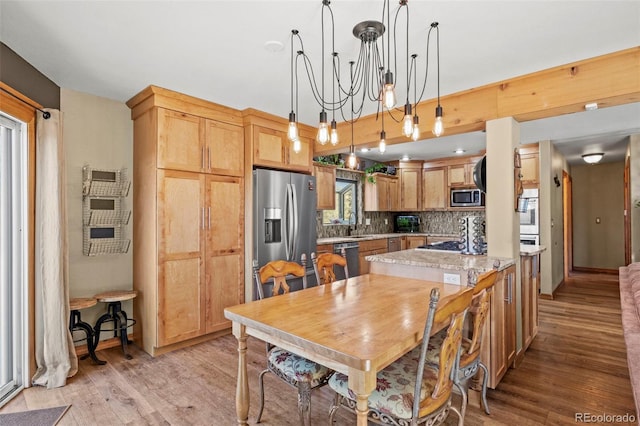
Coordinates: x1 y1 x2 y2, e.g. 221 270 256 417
253 253 333 425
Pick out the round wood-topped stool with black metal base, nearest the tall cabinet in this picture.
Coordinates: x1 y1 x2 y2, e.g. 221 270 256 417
93 290 138 359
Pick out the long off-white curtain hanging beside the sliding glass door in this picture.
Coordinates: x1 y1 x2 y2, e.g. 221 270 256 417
32 110 78 389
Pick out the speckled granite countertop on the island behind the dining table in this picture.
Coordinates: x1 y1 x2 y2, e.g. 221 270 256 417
365 249 515 273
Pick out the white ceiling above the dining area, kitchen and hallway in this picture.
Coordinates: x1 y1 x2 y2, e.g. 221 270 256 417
0 0 640 162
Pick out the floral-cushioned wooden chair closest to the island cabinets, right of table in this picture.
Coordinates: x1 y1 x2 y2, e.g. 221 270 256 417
427 270 498 420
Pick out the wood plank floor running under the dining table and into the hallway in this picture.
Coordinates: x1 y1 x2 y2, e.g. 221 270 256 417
0 274 635 426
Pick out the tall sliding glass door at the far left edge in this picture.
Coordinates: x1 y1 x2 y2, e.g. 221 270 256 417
0 114 28 407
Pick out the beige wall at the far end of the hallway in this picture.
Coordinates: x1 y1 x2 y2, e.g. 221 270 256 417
571 162 624 269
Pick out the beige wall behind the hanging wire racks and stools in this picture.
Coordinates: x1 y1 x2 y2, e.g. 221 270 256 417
60 89 133 330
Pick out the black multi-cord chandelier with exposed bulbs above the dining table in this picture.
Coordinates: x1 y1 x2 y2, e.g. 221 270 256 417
288 0 444 158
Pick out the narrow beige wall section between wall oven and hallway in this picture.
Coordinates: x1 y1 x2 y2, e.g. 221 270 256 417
538 140 570 295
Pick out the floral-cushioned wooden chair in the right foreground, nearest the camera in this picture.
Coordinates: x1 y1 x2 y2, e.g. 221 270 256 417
329 288 472 425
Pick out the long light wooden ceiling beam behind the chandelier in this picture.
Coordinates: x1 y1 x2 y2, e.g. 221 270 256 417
314 46 640 155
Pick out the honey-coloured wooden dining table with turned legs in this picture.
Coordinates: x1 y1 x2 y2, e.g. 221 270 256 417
224 274 466 426
